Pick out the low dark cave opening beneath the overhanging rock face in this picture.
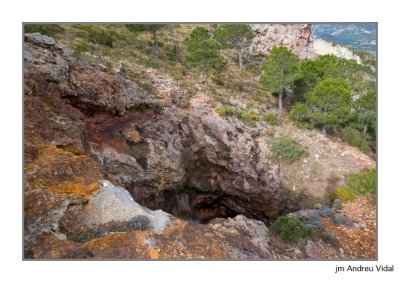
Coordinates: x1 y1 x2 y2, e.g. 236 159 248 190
128 181 300 226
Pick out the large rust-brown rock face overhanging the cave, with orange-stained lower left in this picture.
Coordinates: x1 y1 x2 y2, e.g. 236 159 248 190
24 34 280 254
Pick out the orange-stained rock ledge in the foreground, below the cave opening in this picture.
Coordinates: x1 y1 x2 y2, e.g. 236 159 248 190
25 217 272 259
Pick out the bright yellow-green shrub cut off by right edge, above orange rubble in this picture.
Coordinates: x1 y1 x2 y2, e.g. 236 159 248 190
347 168 376 196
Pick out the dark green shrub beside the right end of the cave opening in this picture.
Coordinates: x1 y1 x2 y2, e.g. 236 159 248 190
270 216 308 243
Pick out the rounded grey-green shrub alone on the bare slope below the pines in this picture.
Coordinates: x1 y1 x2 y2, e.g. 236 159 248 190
271 136 308 164
